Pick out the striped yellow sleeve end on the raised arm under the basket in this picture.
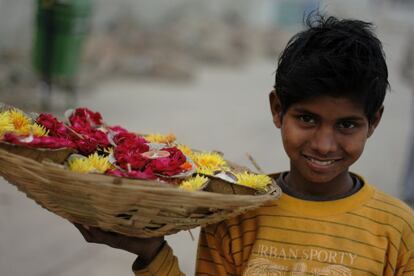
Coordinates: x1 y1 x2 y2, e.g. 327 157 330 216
134 243 184 276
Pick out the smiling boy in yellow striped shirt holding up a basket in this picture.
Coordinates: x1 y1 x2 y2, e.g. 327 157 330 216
77 17 414 275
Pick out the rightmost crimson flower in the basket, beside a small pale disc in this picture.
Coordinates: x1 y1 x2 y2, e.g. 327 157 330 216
148 147 187 176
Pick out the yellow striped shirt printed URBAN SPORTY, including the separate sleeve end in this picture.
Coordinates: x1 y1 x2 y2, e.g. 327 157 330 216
135 178 414 276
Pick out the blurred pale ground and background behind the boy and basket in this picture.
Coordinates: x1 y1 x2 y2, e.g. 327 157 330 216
0 0 414 276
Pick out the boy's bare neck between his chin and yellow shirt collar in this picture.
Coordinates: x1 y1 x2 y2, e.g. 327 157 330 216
285 169 354 199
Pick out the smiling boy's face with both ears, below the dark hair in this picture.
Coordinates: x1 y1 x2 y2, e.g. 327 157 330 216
270 91 382 187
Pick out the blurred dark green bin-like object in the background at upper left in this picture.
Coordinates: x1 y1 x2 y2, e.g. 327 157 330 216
33 0 92 82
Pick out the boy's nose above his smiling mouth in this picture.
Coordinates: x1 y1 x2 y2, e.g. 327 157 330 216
310 127 338 155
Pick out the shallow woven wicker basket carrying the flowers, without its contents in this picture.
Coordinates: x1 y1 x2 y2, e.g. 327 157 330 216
0 149 281 237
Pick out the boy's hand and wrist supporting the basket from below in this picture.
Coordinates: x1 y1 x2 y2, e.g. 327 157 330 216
73 223 164 268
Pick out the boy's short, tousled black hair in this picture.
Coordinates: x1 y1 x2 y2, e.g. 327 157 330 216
274 14 389 121
